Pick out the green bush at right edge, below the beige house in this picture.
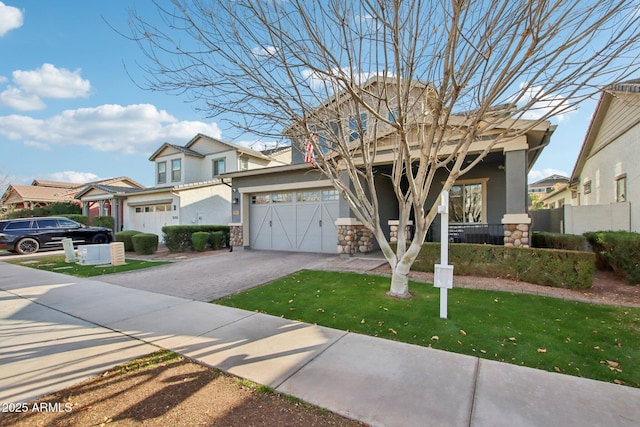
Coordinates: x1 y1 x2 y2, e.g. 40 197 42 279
585 231 640 285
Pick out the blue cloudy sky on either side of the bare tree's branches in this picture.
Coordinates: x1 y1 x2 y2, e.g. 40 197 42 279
0 0 608 186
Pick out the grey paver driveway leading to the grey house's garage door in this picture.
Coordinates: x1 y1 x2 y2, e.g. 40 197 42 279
100 250 335 302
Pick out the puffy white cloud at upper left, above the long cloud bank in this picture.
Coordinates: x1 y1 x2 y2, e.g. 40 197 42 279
0 64 91 111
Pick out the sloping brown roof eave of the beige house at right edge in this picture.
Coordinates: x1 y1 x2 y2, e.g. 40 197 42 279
571 79 640 182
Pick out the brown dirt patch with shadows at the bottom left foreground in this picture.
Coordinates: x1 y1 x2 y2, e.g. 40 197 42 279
0 351 364 427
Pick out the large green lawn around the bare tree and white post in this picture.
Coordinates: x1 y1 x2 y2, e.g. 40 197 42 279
215 270 640 387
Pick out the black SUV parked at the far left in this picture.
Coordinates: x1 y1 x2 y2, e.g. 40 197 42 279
0 217 113 255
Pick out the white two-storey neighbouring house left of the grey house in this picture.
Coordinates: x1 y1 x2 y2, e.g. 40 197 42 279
96 134 290 239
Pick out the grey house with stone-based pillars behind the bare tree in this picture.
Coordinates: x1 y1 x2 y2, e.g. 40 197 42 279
225 78 555 254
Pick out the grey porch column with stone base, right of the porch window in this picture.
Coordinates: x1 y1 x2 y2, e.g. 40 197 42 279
502 140 531 247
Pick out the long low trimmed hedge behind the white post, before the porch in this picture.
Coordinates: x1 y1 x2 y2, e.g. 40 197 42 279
411 243 595 289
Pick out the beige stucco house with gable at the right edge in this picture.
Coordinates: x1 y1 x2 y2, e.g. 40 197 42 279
565 79 640 234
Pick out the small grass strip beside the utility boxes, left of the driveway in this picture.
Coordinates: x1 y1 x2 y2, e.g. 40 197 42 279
9 255 168 277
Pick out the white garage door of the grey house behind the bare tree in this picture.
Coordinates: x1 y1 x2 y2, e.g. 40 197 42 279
249 189 339 253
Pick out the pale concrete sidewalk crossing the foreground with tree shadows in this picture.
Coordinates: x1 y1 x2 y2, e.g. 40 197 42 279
0 262 640 427
